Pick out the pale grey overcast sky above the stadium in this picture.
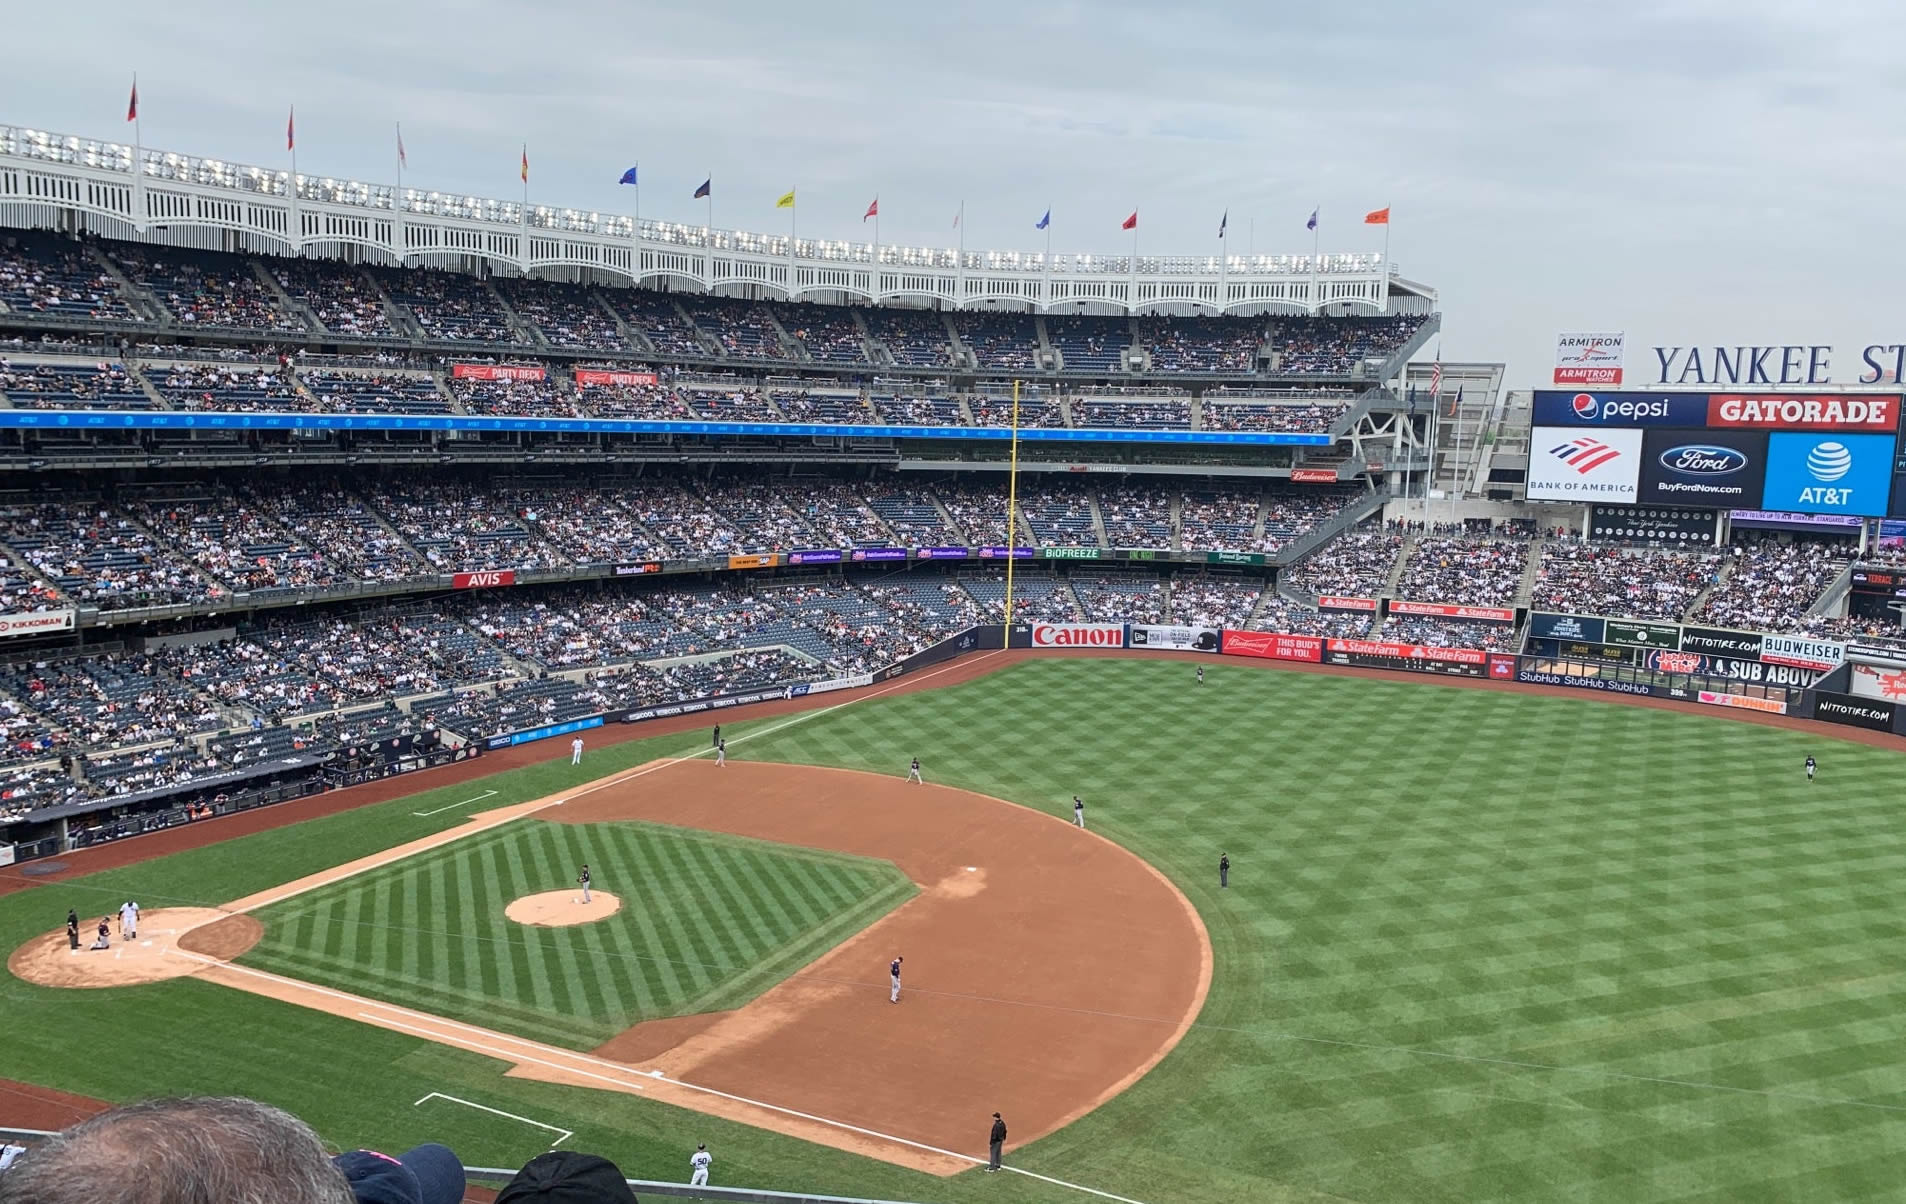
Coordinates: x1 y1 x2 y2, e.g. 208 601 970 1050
14 0 1906 387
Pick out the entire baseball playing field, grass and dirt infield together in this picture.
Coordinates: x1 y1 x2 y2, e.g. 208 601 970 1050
11 657 1906 1204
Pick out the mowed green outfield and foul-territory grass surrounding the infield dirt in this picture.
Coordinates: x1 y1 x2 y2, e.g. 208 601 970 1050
11 659 1906 1204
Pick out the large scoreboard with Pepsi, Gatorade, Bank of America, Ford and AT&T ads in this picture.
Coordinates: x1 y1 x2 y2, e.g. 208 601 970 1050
1529 389 1906 518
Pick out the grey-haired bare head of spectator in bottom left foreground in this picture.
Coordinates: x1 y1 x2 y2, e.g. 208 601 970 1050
0 1095 353 1204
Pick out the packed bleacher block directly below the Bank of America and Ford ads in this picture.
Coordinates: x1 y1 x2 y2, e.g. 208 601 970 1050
1531 541 1721 619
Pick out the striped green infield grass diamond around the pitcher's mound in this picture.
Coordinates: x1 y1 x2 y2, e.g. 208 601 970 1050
242 819 915 1050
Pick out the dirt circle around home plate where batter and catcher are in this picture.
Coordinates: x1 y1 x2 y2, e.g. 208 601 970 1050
6 907 265 987
